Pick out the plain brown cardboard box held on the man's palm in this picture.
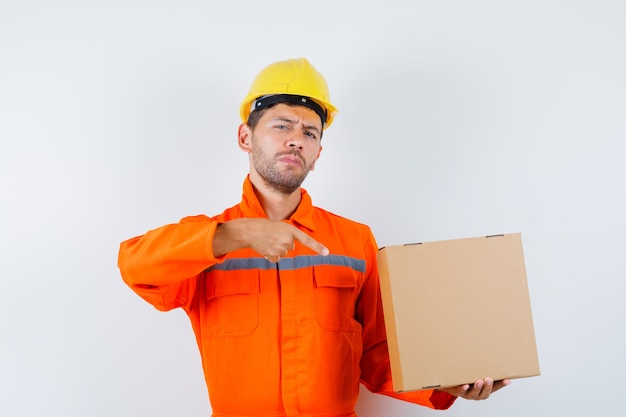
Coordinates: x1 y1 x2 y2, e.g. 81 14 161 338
378 233 539 392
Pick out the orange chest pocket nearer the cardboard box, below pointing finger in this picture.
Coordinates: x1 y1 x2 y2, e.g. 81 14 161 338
313 267 361 332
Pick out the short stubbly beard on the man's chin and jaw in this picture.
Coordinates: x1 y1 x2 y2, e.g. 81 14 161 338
252 148 313 195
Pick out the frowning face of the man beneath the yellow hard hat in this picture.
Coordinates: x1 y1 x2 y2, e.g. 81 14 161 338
239 103 322 195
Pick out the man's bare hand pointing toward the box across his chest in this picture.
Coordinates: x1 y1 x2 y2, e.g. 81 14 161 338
213 218 329 262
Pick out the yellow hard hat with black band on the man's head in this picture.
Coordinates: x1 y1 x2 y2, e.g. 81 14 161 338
239 58 337 129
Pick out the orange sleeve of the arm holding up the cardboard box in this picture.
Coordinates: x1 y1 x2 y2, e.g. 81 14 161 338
357 231 457 410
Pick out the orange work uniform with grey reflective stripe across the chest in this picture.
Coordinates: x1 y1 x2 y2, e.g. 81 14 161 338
119 179 456 417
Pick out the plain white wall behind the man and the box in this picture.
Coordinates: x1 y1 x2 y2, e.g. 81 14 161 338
0 0 626 417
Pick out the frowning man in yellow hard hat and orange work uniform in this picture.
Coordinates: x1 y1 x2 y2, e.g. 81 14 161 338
119 59 508 417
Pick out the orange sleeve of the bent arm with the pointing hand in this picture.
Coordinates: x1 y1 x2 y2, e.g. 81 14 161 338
118 216 221 311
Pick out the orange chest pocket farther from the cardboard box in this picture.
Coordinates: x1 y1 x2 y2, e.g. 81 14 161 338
205 271 259 337
